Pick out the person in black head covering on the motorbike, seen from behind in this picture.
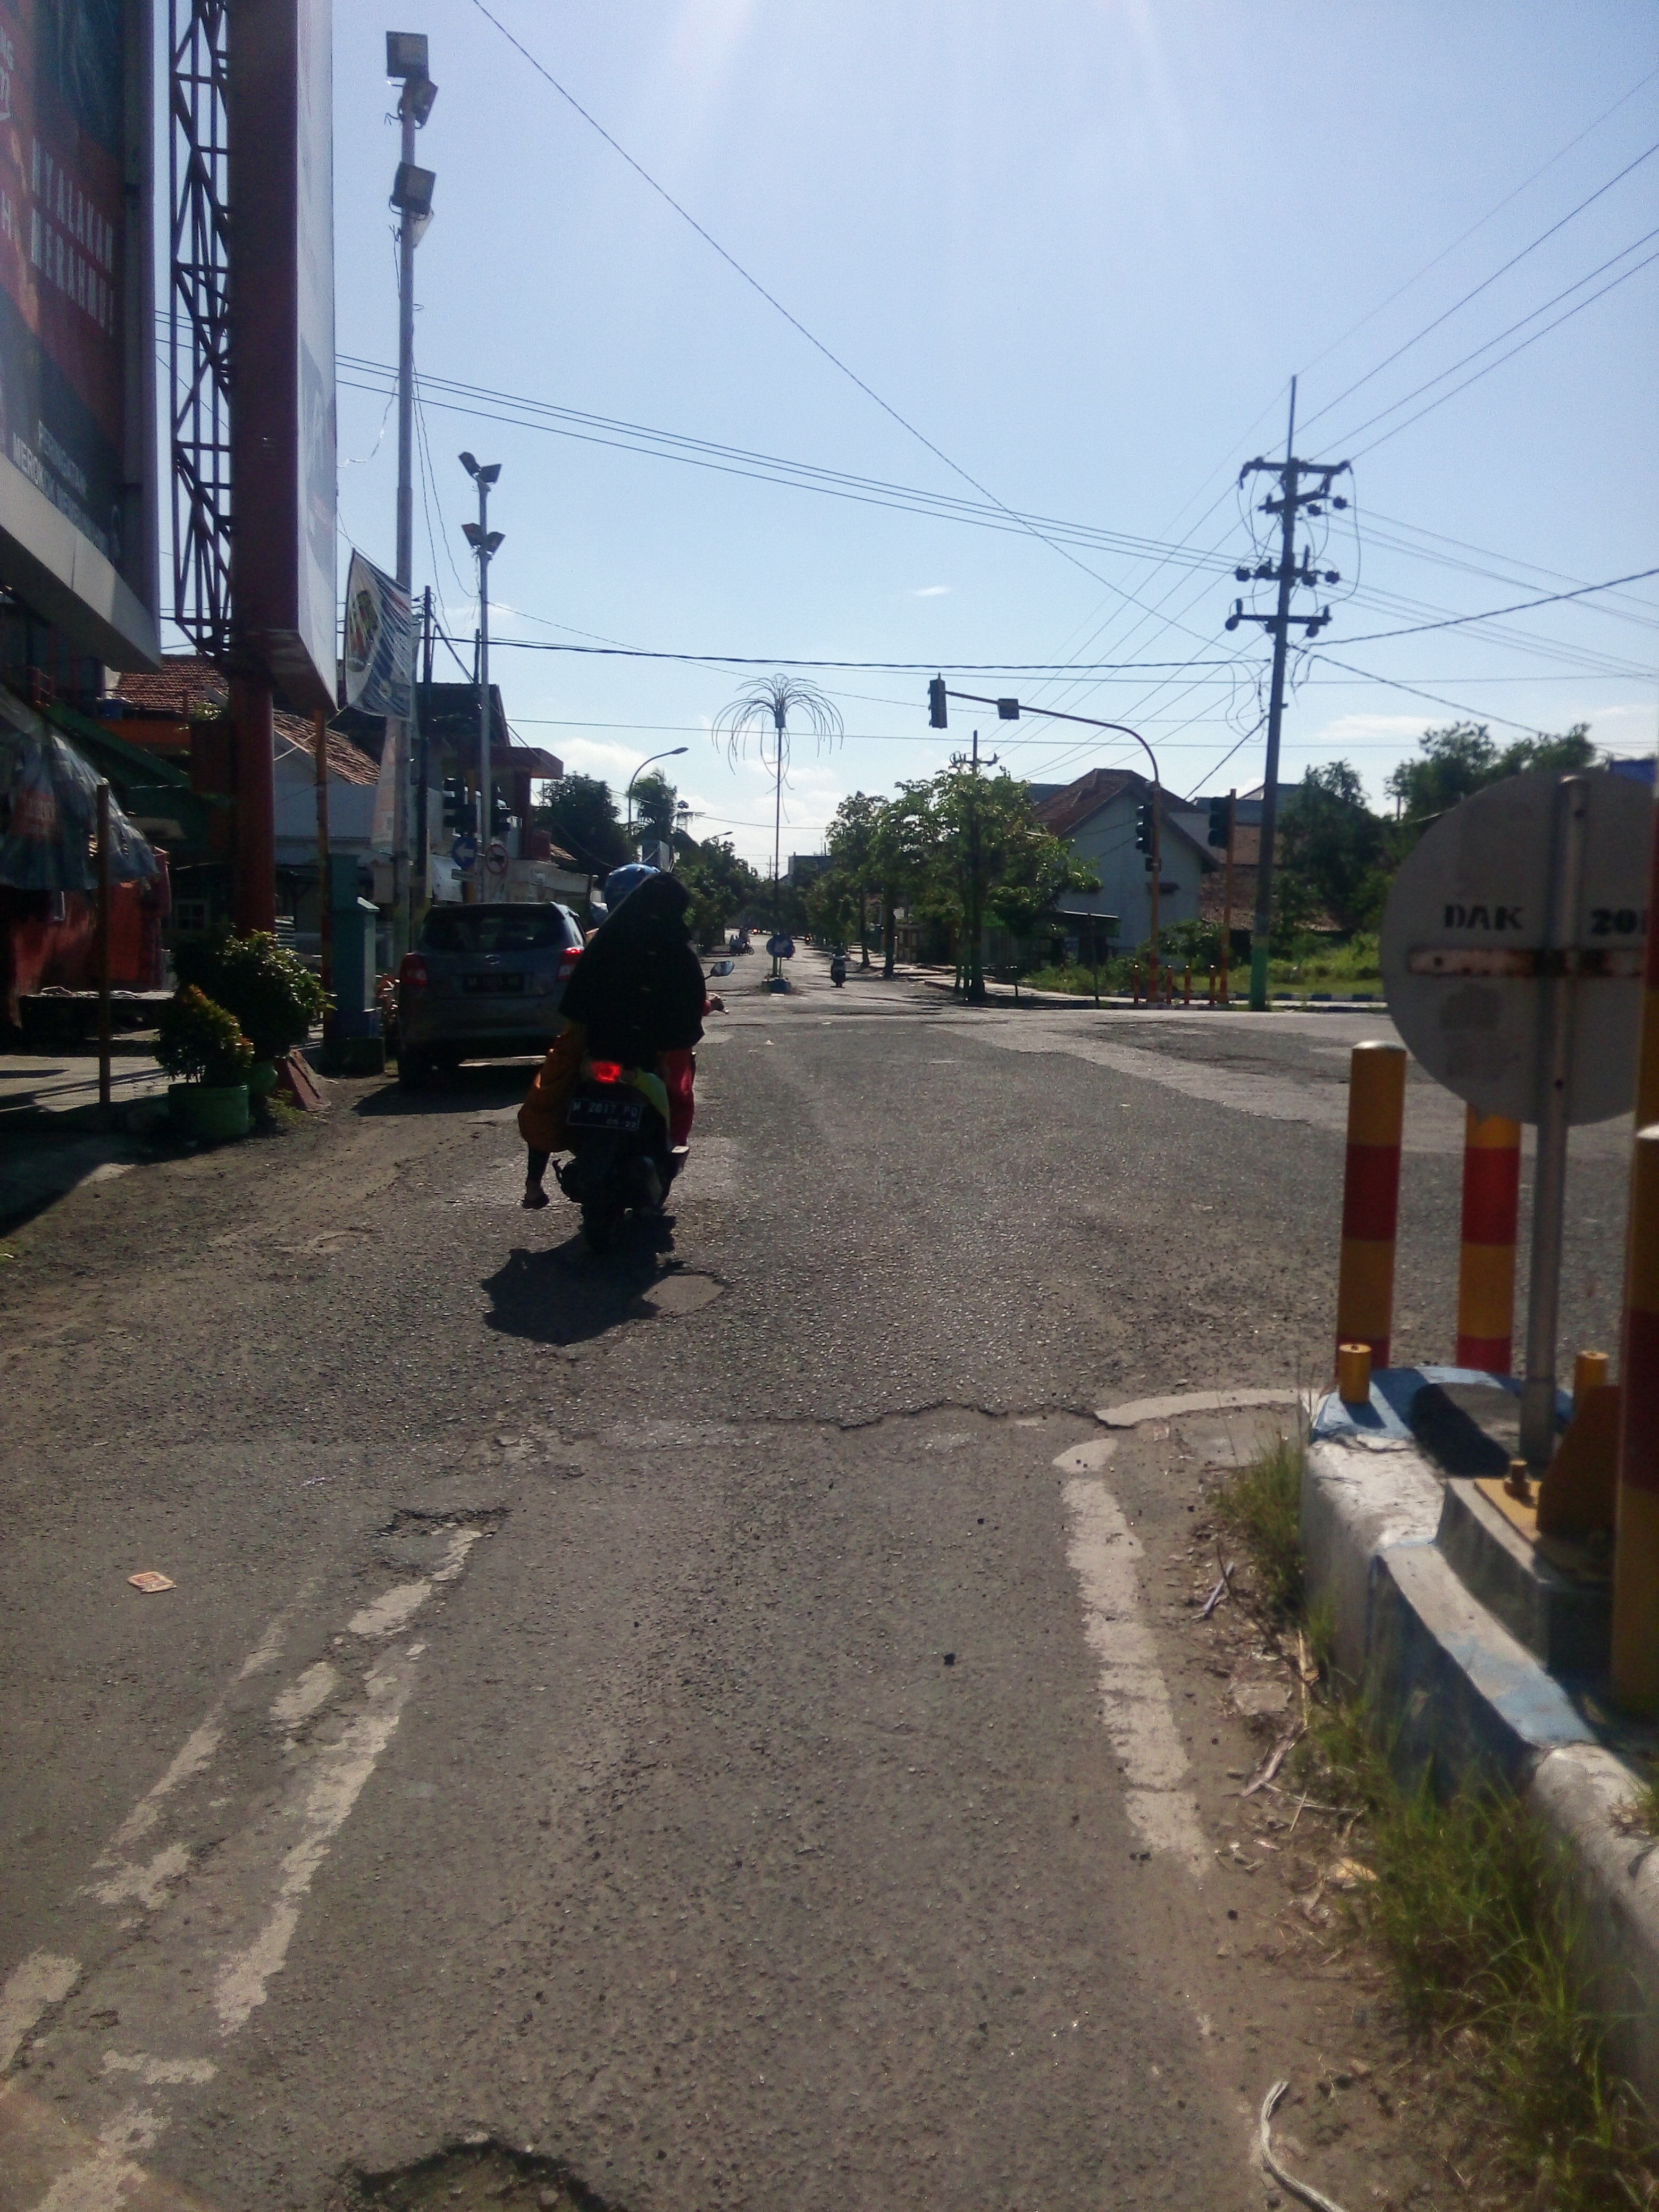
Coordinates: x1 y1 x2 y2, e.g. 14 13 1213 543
520 860 723 1208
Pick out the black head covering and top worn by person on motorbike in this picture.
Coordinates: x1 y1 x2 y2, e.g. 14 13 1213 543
562 876 708 1068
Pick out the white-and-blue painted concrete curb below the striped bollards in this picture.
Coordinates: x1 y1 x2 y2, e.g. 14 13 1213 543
1303 1434 1659 2110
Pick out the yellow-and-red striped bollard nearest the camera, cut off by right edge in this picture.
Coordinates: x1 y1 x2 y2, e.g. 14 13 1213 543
1613 1124 1659 1714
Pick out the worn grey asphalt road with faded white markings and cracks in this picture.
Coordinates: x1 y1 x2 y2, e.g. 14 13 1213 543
0 956 1623 2212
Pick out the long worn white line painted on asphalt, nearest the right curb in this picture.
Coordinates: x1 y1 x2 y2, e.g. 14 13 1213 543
1055 1453 1208 1876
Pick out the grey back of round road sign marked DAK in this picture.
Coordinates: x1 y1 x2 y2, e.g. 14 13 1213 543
1382 768 1655 1121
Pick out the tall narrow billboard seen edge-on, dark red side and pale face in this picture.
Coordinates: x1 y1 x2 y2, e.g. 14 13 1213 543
231 0 336 710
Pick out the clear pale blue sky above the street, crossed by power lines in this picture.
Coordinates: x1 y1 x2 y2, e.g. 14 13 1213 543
175 0 1659 865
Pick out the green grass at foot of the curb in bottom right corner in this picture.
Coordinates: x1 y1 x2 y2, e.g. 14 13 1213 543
1310 1703 1659 2212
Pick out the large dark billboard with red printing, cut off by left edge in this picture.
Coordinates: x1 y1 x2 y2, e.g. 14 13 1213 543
0 0 160 668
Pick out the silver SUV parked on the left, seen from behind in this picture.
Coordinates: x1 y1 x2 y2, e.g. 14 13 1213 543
398 904 582 1088
